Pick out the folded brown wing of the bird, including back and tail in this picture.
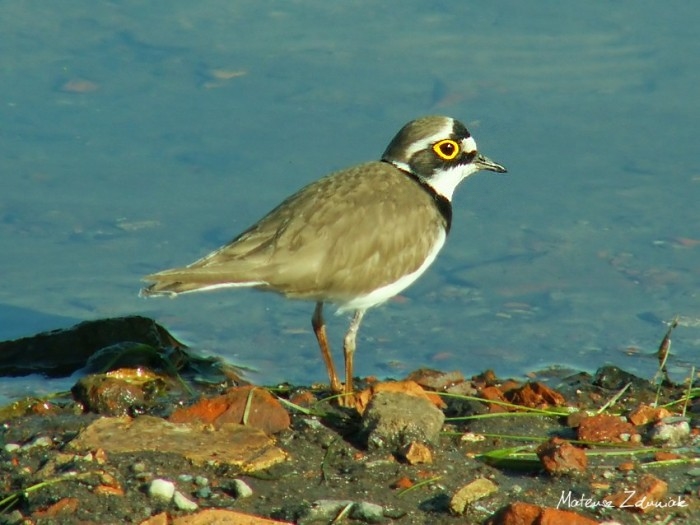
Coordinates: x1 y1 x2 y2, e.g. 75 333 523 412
146 162 444 301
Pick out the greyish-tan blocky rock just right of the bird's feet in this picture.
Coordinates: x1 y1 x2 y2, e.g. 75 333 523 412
361 392 445 453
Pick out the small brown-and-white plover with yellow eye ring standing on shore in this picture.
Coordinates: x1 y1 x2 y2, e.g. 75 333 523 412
140 115 507 404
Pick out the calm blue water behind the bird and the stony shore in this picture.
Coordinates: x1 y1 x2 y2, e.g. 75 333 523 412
0 0 700 397
